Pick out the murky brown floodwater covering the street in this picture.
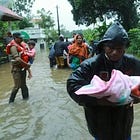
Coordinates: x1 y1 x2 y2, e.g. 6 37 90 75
0 51 140 140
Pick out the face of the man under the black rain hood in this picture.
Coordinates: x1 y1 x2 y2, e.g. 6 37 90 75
104 45 125 61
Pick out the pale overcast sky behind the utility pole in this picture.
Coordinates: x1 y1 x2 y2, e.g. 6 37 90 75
32 0 92 31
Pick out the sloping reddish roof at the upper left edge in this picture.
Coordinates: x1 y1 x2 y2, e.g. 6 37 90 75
0 5 22 21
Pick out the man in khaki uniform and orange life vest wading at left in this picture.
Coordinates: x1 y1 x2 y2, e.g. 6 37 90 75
6 32 31 103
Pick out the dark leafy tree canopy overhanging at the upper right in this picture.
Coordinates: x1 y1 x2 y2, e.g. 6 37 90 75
68 0 140 30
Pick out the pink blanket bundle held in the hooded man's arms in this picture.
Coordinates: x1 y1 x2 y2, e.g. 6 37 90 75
75 69 140 103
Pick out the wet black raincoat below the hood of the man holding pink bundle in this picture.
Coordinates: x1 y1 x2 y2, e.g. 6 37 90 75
67 53 140 140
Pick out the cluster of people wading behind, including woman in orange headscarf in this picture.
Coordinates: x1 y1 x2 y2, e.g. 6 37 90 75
49 33 95 70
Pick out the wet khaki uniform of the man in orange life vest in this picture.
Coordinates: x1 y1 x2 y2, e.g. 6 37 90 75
9 40 29 103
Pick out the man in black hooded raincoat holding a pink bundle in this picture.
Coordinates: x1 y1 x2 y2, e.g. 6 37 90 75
67 22 140 140
